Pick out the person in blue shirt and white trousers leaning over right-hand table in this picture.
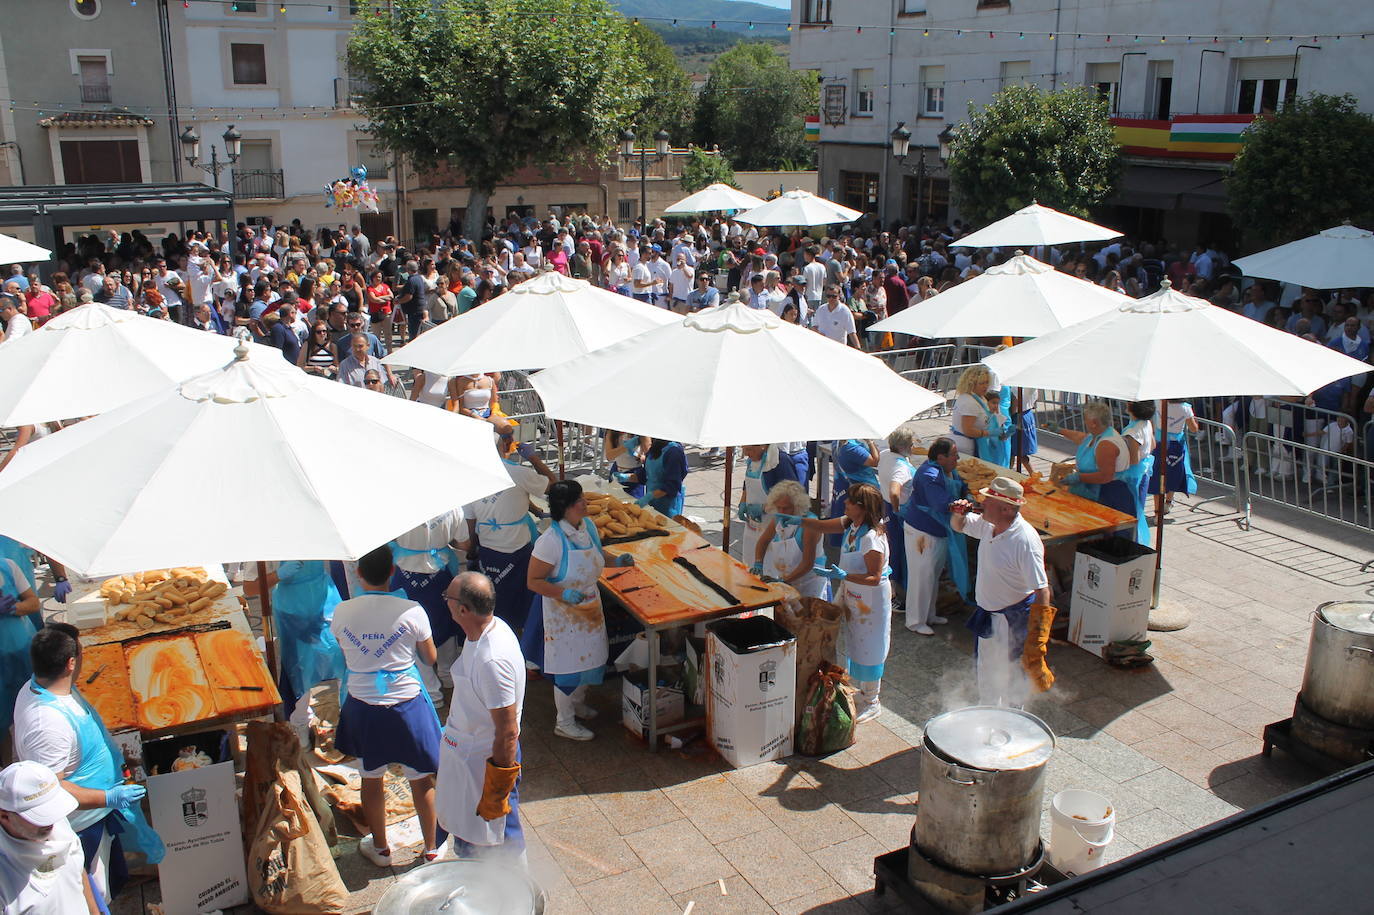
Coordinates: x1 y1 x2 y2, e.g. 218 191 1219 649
901 436 973 636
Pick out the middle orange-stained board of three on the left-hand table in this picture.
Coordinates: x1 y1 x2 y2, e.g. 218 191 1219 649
124 636 214 731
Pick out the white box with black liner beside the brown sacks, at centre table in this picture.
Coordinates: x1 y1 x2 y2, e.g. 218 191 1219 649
706 617 797 768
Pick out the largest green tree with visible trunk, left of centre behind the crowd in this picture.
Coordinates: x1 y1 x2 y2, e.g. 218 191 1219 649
348 0 644 236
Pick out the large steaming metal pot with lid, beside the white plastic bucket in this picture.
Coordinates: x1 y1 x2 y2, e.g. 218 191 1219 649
912 705 1054 877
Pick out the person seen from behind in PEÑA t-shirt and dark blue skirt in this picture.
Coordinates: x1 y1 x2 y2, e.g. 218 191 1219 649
330 545 447 867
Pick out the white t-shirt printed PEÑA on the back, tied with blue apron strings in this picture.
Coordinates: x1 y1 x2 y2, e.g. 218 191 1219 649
330 592 434 705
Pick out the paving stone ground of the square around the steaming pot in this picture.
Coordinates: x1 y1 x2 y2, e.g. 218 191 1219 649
115 423 1374 915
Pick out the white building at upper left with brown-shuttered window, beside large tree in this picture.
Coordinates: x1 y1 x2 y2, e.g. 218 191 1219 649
169 0 396 239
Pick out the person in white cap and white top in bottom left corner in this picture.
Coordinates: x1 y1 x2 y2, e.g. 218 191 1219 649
0 761 100 915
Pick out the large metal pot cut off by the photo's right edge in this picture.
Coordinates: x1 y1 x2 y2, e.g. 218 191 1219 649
1301 600 1374 730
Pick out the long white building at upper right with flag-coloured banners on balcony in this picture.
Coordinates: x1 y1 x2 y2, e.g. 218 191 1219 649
791 0 1374 240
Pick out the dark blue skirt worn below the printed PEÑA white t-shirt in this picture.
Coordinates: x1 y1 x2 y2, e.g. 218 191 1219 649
334 692 441 772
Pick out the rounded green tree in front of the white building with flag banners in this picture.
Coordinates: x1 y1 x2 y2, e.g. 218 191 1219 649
949 85 1121 223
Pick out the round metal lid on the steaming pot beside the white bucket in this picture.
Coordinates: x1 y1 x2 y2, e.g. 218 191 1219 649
926 705 1054 771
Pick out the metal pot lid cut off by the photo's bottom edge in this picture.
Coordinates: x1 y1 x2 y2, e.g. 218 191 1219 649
372 859 544 915
